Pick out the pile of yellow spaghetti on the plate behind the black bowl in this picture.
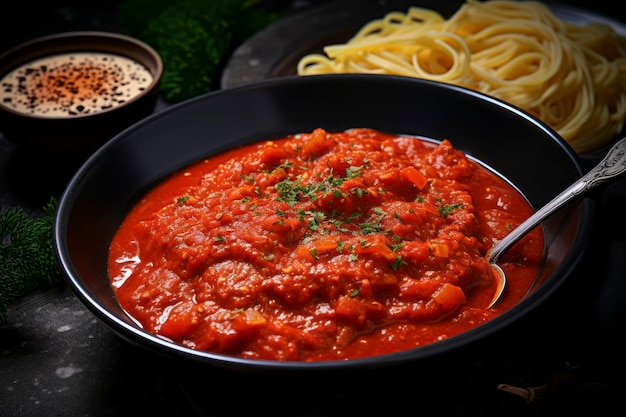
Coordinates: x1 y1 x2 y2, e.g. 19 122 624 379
297 0 626 153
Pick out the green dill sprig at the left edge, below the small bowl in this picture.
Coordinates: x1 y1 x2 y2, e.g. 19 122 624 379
0 198 61 322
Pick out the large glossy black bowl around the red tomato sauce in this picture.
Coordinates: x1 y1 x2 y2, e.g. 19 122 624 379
54 74 593 373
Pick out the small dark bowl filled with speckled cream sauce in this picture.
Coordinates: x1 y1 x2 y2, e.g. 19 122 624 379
0 32 163 153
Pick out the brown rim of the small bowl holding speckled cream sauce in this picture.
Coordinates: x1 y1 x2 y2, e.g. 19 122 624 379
0 31 164 121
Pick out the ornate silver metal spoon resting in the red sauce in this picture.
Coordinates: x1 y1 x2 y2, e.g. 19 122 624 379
487 138 626 308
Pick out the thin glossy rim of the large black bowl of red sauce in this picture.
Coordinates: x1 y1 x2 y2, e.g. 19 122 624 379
53 74 594 373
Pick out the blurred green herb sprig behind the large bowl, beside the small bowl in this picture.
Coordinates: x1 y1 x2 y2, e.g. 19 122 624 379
118 0 278 103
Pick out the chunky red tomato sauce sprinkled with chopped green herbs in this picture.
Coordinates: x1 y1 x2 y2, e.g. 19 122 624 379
109 129 543 361
